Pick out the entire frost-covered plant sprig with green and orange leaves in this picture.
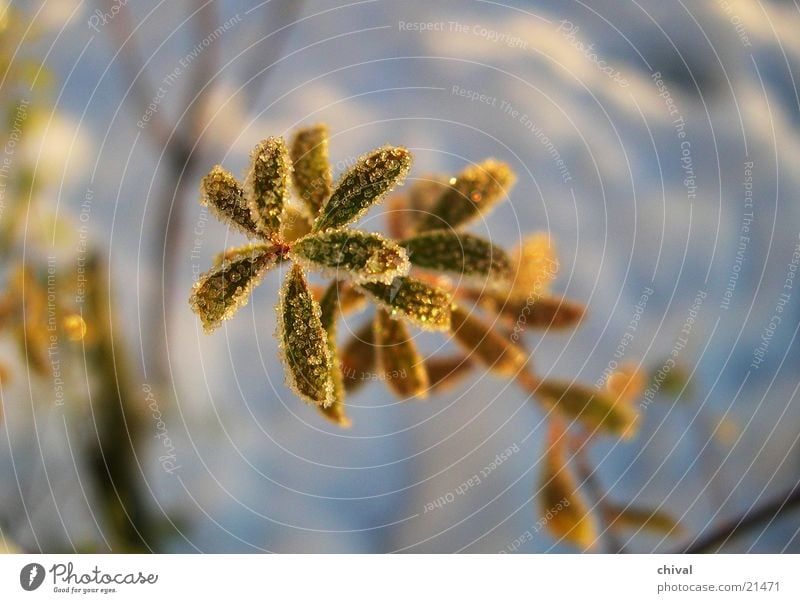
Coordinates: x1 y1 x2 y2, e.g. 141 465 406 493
190 125 674 548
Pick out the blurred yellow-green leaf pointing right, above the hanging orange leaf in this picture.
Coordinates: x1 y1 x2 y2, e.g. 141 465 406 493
533 380 638 437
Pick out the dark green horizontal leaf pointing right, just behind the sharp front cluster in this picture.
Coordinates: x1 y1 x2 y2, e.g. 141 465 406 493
402 230 512 280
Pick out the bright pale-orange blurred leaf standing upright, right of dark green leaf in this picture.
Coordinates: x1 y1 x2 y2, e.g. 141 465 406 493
509 232 559 300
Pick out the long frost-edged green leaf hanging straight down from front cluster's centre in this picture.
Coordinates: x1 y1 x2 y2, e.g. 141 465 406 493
278 264 333 406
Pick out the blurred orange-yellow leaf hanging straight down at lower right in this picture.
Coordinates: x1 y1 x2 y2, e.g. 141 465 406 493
539 431 598 550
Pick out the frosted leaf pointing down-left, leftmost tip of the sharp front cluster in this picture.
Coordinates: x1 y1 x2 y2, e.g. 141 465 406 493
189 245 282 333
